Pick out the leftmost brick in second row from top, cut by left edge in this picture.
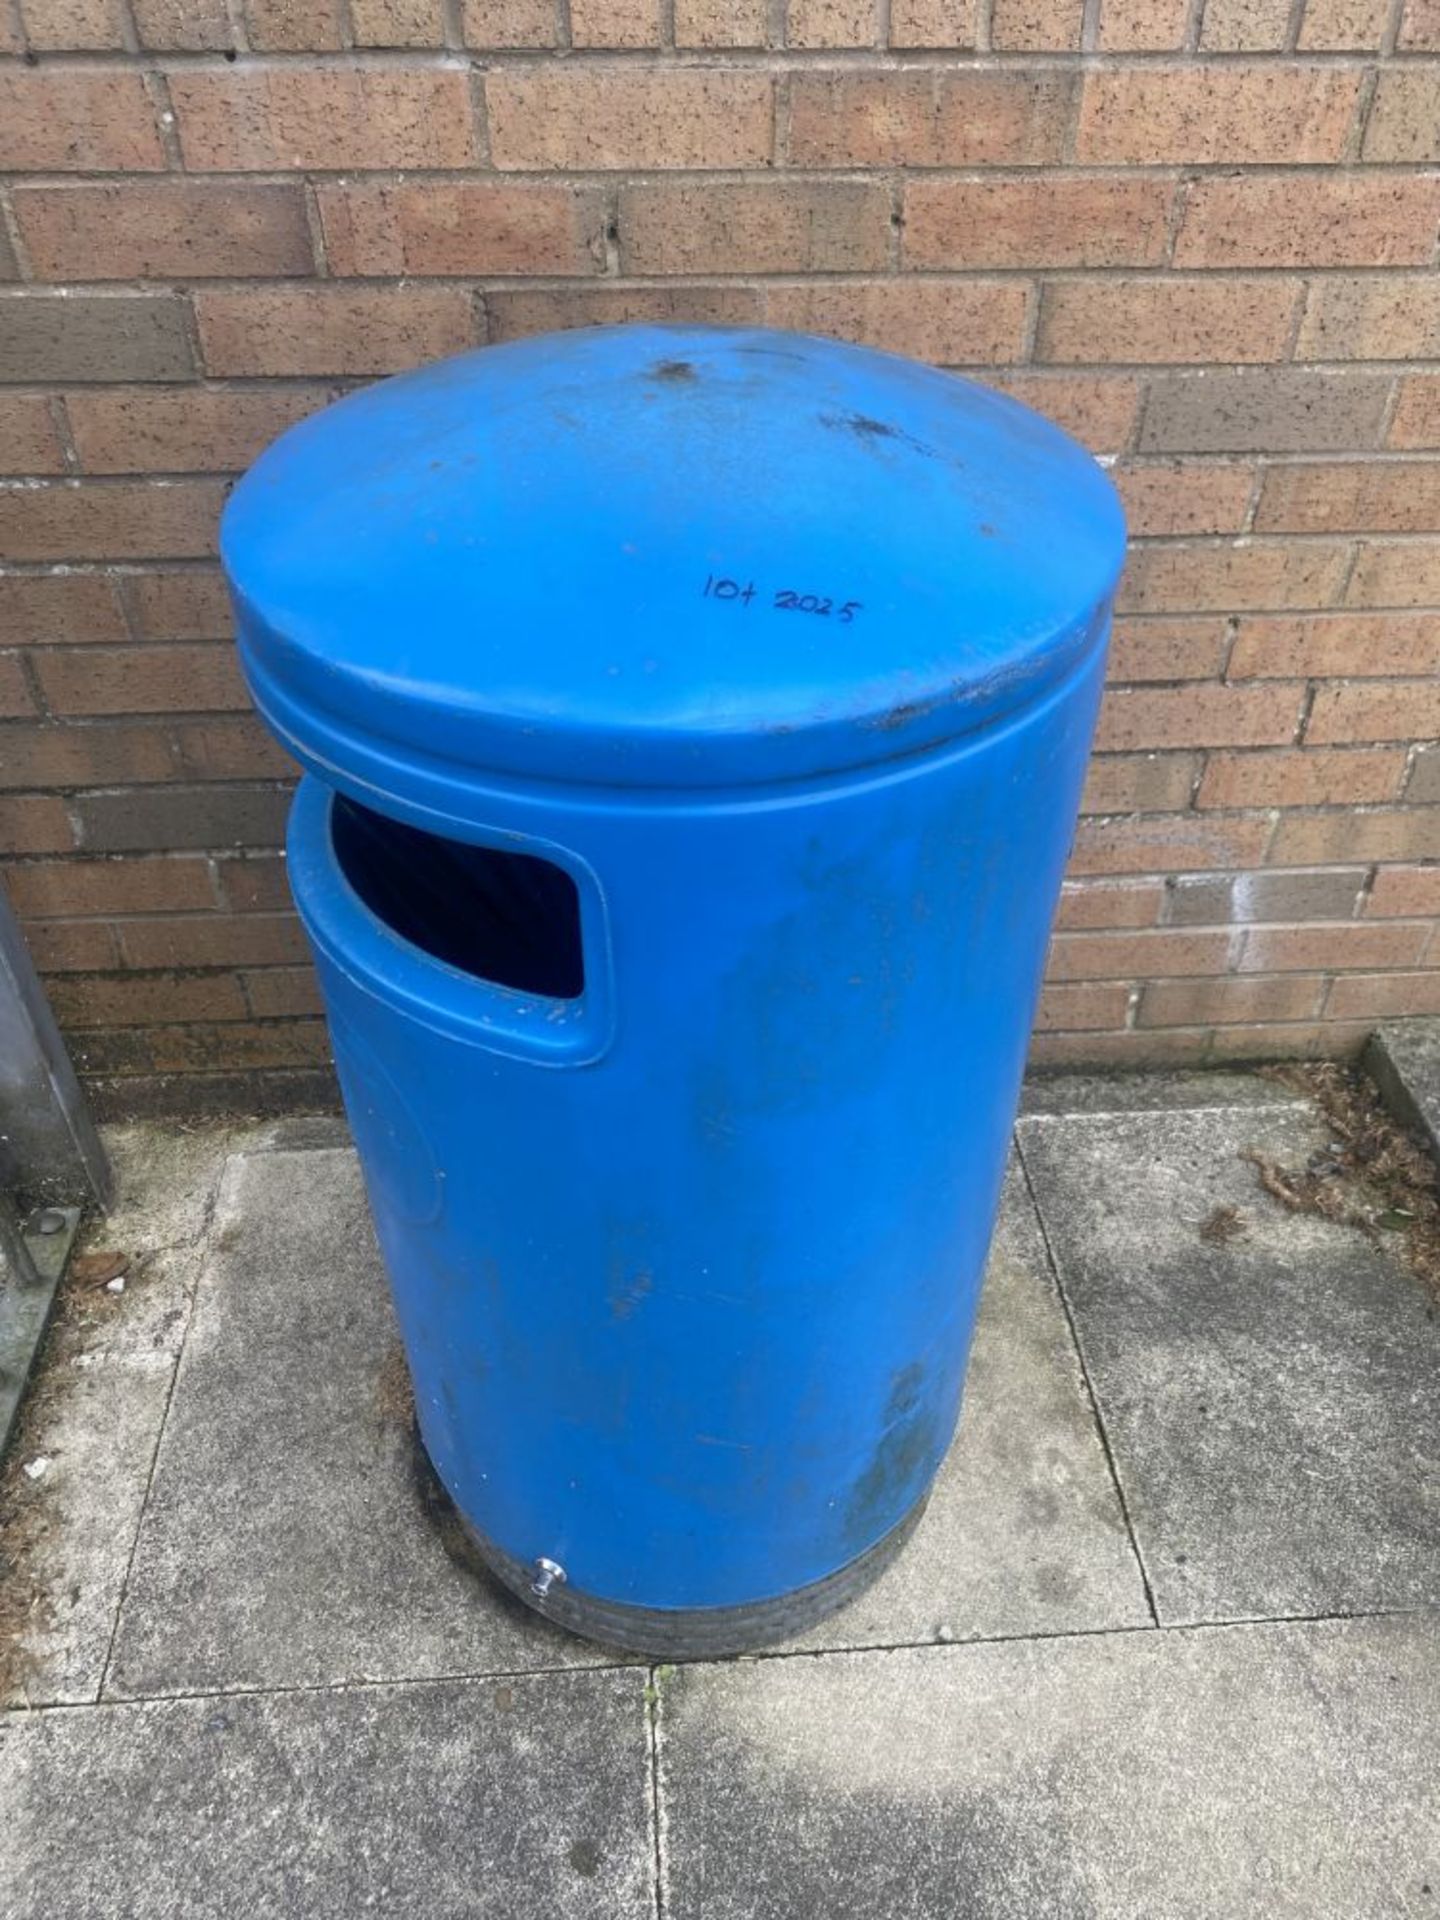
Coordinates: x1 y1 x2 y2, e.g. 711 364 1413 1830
0 65 165 173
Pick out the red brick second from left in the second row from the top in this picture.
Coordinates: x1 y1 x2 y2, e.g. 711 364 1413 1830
169 65 480 173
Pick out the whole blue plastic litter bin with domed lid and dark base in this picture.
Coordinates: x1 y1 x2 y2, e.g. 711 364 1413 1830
223 326 1123 1655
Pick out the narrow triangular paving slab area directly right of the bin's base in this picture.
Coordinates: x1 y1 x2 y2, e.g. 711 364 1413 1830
791 1165 1150 1647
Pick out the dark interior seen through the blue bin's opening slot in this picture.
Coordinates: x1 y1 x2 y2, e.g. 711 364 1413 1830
330 797 586 1000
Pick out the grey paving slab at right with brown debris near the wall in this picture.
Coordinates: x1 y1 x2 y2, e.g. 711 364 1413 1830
1020 1108 1440 1628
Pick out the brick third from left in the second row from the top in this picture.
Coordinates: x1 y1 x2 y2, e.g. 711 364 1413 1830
486 63 774 171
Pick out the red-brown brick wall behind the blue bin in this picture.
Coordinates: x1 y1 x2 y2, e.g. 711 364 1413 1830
0 0 1440 1102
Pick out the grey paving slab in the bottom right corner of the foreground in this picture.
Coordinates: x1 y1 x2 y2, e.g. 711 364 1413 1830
659 1617 1440 1920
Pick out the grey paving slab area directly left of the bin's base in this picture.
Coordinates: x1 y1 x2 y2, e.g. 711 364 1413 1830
108 1150 625 1697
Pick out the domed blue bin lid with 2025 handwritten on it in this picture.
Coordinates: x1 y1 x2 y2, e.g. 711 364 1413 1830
221 324 1125 785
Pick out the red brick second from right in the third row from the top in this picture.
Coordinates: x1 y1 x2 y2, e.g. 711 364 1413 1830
902 173 1173 269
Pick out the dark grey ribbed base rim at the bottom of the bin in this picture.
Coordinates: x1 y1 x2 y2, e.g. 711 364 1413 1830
415 1430 929 1661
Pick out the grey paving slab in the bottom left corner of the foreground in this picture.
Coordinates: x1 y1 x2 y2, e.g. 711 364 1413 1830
0 1672 653 1920
